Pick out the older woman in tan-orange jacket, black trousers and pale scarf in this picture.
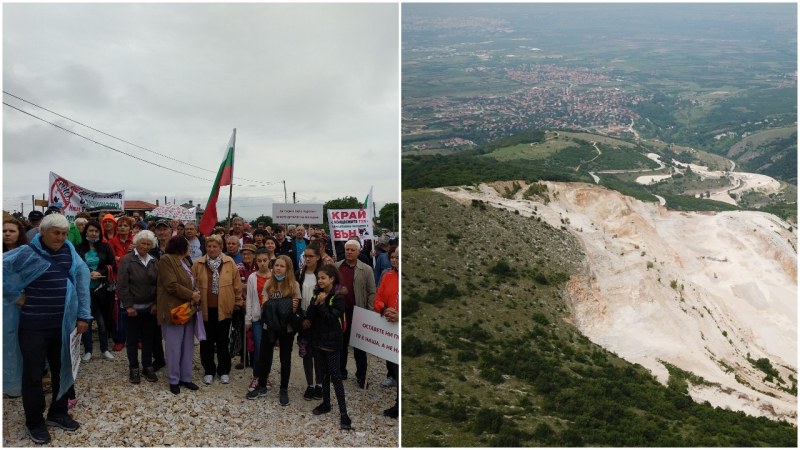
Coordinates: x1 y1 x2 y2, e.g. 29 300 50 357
194 234 244 384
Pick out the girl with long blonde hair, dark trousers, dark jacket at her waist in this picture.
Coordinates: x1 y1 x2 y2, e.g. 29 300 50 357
247 255 301 406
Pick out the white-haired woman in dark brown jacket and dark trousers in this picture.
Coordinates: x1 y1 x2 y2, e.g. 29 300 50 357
117 232 160 384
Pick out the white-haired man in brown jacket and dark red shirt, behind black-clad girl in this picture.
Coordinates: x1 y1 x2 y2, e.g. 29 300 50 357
336 239 375 389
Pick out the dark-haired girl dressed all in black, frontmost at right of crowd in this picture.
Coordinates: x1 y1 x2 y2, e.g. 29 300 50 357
307 265 352 430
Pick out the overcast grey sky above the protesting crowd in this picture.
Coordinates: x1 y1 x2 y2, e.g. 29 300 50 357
2 3 400 220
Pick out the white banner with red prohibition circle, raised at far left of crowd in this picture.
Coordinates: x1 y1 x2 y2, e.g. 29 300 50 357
50 172 125 222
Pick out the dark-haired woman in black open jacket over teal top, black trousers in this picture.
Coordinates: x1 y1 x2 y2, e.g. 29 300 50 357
76 220 117 361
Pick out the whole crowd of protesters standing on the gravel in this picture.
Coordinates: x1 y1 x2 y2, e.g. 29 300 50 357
3 207 399 444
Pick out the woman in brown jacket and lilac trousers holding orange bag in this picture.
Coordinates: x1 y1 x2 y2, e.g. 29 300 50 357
156 236 200 394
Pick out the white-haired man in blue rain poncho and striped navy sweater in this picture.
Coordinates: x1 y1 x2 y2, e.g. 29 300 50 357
3 214 92 444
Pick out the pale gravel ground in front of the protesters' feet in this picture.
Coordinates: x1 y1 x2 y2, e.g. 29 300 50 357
3 343 399 447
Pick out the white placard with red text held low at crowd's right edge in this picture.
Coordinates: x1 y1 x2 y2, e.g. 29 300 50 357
347 306 400 364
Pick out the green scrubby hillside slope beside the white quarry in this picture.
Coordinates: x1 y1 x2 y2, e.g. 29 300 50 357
402 190 797 447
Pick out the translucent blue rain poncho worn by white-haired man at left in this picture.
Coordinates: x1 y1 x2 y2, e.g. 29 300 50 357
3 234 92 398
